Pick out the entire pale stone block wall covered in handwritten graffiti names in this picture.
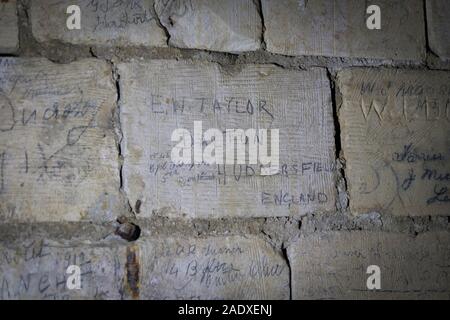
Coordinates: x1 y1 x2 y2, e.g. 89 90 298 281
0 0 450 299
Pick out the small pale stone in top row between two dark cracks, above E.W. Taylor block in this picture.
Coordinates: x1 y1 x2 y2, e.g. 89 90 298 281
155 0 262 52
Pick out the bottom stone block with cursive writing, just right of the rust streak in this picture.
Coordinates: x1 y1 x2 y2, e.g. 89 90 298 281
140 237 289 300
